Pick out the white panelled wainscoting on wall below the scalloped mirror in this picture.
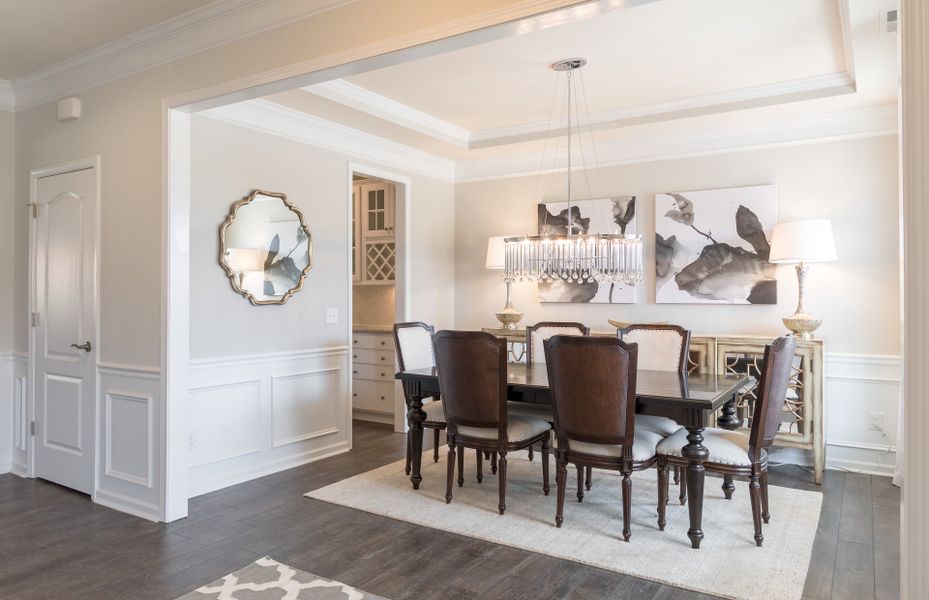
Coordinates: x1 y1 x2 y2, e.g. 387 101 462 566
188 346 351 497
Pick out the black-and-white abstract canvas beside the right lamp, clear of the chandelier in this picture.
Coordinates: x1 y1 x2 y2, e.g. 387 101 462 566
655 185 777 304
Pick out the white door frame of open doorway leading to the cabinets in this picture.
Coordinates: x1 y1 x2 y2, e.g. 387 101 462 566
346 162 413 440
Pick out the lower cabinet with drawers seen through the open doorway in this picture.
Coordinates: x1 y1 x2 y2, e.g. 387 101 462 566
352 332 395 424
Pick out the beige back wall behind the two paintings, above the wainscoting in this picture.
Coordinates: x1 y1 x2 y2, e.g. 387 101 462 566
455 136 900 355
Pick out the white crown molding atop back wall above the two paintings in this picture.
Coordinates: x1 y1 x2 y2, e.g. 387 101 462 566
455 104 898 183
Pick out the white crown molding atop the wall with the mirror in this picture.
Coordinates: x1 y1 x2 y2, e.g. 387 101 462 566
208 99 455 182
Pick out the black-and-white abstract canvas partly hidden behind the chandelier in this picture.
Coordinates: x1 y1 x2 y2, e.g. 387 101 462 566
538 196 636 304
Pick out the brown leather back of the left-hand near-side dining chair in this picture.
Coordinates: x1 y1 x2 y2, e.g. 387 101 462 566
433 331 507 440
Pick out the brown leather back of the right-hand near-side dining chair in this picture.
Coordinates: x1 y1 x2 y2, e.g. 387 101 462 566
544 335 637 450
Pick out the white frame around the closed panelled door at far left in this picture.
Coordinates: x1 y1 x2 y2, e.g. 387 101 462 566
23 155 102 482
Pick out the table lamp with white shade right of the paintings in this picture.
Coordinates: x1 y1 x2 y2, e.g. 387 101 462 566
768 219 836 339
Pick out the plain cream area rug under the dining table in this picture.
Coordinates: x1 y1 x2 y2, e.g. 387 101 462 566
306 450 822 600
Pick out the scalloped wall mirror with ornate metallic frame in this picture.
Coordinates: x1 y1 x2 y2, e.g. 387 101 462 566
219 190 313 304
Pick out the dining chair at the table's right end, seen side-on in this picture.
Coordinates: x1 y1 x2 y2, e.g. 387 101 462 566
657 335 797 546
